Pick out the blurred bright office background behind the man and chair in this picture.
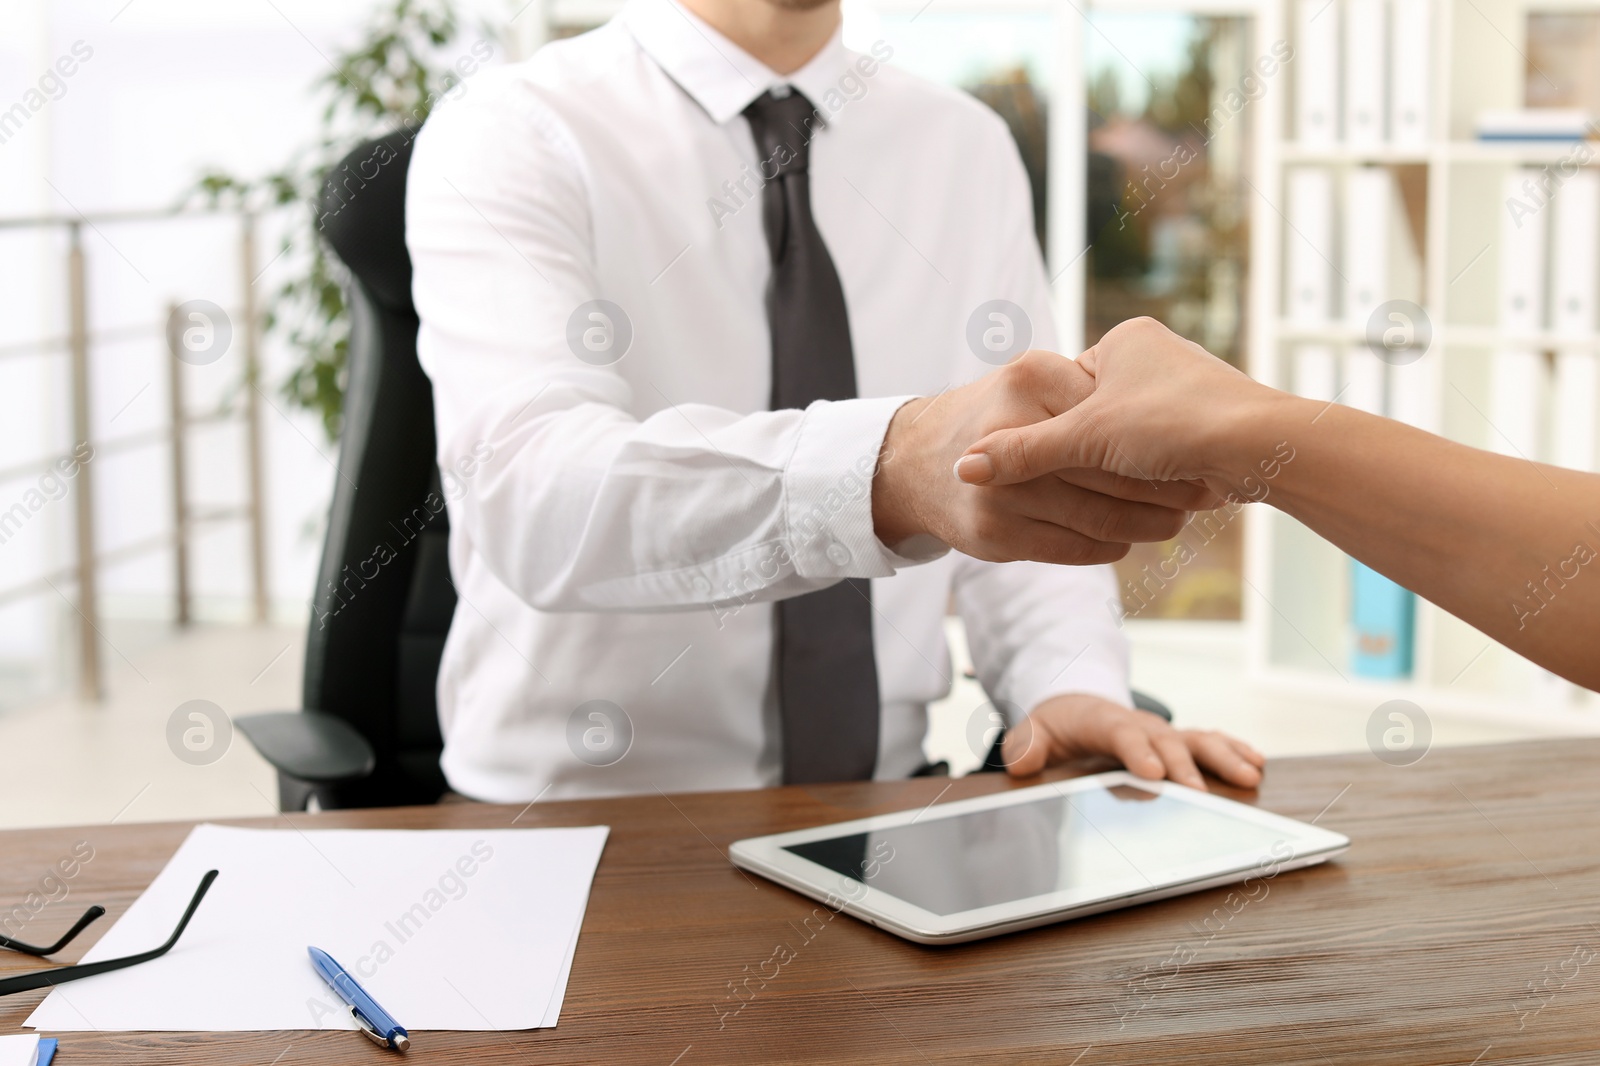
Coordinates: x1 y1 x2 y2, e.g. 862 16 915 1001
0 0 1600 824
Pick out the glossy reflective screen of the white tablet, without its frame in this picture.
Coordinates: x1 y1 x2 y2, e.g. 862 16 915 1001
786 784 1285 914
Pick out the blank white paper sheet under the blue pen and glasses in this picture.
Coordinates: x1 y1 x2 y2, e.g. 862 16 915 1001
26 824 608 1032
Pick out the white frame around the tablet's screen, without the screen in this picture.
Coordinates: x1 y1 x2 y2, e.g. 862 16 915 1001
728 770 1350 944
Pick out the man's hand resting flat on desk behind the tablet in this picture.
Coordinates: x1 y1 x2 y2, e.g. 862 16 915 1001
1000 693 1267 789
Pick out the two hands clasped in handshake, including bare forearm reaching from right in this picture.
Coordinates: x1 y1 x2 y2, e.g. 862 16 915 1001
872 319 1600 688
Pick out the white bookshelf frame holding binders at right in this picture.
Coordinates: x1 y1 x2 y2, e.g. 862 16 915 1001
1243 0 1600 728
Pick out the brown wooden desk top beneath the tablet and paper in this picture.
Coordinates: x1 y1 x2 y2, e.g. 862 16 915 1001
0 739 1600 1066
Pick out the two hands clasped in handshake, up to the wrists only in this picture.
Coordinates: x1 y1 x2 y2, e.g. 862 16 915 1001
872 319 1275 565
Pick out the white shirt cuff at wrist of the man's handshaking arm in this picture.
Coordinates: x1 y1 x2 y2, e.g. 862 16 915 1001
784 395 950 579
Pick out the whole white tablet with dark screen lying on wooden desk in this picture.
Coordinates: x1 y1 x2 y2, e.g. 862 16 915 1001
730 771 1350 944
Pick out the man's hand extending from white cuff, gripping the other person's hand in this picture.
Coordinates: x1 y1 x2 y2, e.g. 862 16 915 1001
872 351 1210 563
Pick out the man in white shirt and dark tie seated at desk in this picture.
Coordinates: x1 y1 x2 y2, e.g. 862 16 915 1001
406 0 1262 802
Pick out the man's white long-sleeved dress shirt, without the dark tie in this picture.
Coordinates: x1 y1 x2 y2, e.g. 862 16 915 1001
406 0 1128 802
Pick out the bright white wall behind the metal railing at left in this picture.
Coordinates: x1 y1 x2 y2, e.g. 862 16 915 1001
0 0 504 698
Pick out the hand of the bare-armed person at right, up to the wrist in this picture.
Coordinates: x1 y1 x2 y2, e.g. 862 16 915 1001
955 319 1272 496
